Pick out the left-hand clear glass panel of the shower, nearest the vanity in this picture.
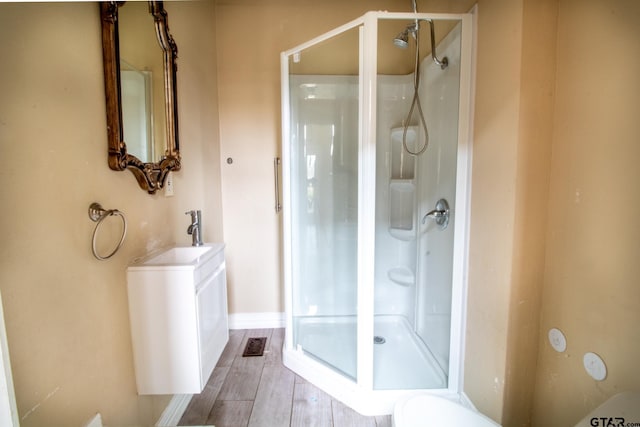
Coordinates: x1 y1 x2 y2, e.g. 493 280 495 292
285 28 359 380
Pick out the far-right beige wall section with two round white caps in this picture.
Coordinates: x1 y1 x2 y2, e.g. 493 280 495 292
533 0 640 427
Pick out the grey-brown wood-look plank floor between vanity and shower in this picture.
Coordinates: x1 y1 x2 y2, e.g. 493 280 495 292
178 329 391 427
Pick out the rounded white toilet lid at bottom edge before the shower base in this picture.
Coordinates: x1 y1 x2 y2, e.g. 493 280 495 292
393 394 500 427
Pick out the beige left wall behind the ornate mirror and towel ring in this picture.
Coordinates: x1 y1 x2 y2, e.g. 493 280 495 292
0 2 222 427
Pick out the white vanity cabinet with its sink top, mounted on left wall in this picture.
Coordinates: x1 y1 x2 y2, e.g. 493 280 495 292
127 243 229 394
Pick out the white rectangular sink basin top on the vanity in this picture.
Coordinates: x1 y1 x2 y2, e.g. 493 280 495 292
129 243 224 269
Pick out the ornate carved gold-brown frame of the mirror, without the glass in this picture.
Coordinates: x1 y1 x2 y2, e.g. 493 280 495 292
100 1 181 194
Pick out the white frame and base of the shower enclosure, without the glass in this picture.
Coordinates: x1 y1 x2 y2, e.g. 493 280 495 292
280 7 476 415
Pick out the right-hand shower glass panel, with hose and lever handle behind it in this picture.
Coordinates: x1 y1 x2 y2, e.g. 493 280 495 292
373 20 462 390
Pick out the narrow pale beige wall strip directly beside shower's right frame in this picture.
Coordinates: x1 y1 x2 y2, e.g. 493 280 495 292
464 0 523 421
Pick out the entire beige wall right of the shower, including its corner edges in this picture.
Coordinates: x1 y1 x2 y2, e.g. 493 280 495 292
465 0 640 426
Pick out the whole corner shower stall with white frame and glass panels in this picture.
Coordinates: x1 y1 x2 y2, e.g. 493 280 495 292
281 12 473 415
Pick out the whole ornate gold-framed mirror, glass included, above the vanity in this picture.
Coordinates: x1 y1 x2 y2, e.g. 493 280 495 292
100 1 180 194
